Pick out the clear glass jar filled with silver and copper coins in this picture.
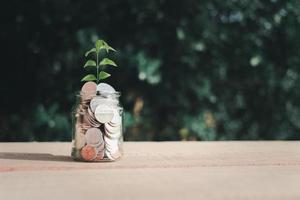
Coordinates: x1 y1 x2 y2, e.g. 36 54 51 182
72 92 123 162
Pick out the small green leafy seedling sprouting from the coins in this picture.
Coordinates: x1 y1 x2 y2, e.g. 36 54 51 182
81 40 117 84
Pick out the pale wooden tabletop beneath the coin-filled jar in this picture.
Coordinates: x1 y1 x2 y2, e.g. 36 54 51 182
0 142 300 200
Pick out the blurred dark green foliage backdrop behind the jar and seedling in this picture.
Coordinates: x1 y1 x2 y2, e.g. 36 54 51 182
0 0 300 141
